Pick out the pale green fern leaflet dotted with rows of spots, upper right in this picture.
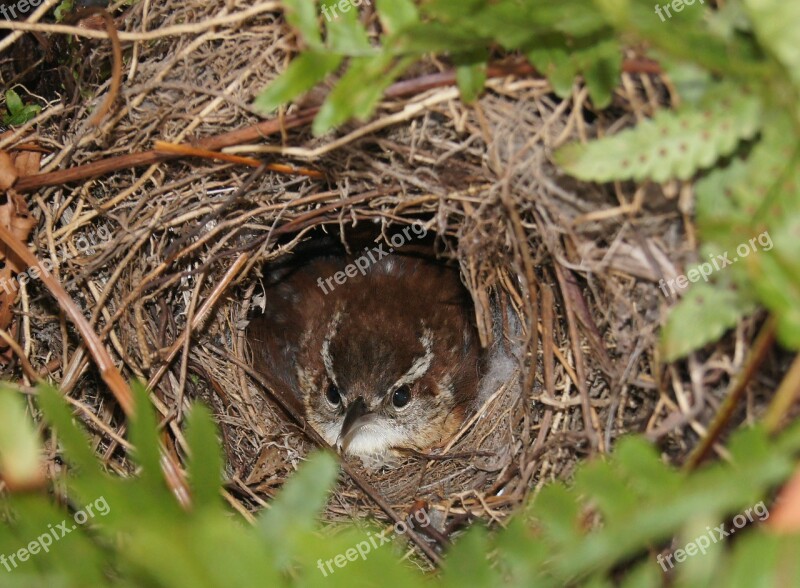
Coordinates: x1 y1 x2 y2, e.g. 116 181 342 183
556 85 761 182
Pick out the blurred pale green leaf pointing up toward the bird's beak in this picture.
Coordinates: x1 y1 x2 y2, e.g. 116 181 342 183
258 452 339 568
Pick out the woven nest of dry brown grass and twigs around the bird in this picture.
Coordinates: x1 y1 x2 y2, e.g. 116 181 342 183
0 0 776 548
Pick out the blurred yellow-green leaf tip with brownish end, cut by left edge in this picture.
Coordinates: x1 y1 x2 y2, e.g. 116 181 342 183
0 382 44 488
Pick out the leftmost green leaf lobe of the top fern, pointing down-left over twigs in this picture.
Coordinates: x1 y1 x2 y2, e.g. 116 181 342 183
253 51 342 113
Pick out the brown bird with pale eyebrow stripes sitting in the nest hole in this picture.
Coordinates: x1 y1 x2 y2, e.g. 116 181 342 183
246 227 485 465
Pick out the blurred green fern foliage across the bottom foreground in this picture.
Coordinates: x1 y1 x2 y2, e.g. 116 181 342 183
0 386 800 588
